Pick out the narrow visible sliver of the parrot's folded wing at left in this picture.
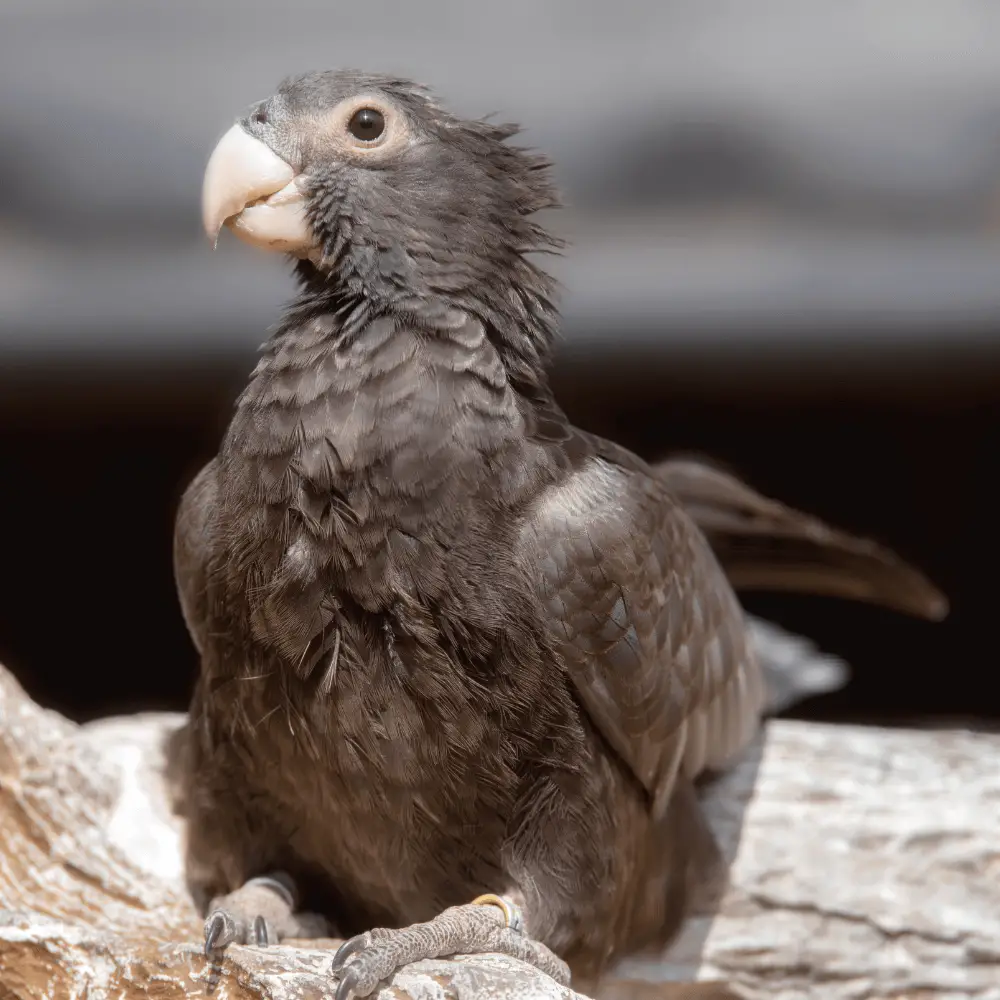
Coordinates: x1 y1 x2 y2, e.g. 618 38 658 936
174 459 216 653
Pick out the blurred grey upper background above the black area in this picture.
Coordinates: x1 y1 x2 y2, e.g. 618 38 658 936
0 0 1000 377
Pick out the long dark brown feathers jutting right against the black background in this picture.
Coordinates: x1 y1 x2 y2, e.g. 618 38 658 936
655 458 948 621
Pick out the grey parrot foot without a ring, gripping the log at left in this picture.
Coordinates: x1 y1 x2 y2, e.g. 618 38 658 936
205 872 327 957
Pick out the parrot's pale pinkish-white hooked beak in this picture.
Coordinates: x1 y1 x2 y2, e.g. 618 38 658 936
201 124 316 257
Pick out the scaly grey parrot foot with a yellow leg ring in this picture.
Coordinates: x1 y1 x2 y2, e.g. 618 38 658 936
331 895 570 1000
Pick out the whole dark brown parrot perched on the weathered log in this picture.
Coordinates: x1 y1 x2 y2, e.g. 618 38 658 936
176 73 948 997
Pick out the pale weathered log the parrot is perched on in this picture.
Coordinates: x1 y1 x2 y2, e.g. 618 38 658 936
0 668 1000 1000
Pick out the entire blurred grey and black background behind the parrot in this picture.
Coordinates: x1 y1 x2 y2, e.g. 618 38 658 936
0 0 1000 726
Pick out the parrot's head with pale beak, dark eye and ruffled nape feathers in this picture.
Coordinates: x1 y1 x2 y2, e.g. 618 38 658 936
202 71 559 298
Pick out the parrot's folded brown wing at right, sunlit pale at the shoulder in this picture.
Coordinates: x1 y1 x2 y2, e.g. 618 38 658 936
521 456 764 809
